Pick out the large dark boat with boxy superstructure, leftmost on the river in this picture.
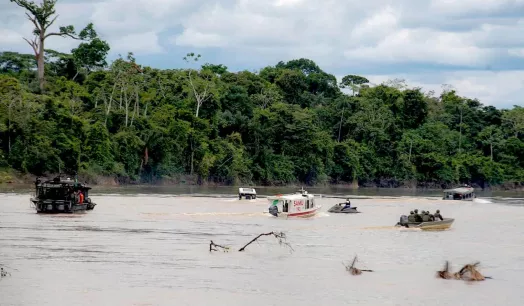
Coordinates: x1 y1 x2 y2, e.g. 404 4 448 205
31 175 96 213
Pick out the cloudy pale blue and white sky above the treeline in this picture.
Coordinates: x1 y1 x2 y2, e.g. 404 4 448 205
0 0 524 108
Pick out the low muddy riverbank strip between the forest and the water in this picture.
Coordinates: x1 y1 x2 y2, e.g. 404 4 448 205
0 169 524 191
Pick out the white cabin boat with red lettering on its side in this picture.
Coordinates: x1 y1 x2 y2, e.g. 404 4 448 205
267 188 322 219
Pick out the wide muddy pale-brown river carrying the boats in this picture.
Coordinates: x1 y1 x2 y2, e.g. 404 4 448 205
0 187 524 306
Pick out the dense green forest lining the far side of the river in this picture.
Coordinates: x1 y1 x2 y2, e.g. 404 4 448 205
0 0 524 187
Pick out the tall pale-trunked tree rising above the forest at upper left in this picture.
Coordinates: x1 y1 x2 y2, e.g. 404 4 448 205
10 0 96 91
